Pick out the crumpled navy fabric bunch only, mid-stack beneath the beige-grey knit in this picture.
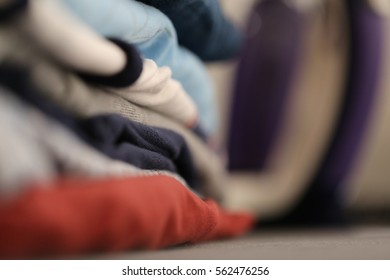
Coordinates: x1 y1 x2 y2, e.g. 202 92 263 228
79 114 197 187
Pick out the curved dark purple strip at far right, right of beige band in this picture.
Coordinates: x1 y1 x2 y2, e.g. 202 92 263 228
278 0 385 223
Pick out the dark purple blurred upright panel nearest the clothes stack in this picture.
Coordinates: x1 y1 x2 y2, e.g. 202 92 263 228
228 0 304 170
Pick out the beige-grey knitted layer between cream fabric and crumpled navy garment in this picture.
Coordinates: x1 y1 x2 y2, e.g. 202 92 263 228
31 59 224 196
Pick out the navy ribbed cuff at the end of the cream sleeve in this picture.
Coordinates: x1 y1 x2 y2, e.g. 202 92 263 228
79 38 143 88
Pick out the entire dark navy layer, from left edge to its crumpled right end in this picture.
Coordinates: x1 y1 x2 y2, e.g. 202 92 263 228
0 64 198 188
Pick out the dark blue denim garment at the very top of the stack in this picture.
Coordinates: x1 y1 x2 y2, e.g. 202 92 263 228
138 0 242 61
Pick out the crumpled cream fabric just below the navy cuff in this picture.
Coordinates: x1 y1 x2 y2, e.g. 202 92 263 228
108 59 198 127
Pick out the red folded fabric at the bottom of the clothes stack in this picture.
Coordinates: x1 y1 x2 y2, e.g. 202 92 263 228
0 175 254 259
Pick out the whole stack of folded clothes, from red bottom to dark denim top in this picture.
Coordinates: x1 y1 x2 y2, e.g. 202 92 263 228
0 0 254 258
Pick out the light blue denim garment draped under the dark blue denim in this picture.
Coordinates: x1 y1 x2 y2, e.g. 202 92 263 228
61 0 218 134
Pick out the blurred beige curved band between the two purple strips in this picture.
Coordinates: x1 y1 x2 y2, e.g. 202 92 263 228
224 0 347 219
